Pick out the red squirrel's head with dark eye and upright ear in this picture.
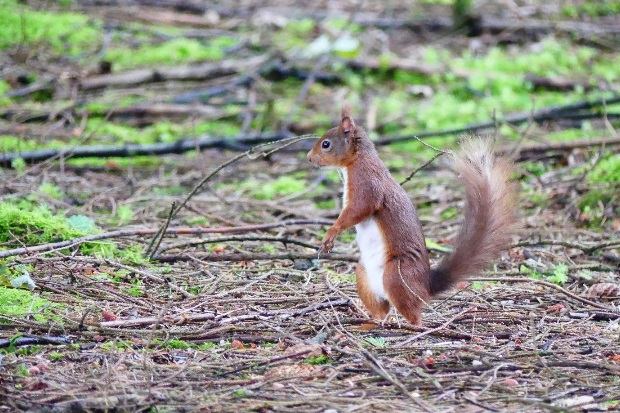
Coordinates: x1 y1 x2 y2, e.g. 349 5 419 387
308 105 363 168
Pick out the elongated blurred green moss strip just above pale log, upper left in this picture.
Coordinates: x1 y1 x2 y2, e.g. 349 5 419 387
105 36 237 70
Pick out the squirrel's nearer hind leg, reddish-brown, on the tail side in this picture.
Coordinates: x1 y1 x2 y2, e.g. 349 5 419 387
383 258 430 326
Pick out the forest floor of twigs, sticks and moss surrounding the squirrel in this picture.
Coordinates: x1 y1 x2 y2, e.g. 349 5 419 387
0 0 620 413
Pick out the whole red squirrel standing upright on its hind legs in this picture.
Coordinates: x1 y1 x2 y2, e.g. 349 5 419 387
308 107 515 325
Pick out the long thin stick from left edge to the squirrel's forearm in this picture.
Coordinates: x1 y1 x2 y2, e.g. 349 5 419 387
0 219 333 258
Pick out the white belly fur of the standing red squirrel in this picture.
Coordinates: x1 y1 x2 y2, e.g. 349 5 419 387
355 218 388 300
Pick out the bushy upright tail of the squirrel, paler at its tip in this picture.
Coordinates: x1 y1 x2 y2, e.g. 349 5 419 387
431 138 516 295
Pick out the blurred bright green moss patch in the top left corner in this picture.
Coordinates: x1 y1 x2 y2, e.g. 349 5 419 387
0 0 102 56
